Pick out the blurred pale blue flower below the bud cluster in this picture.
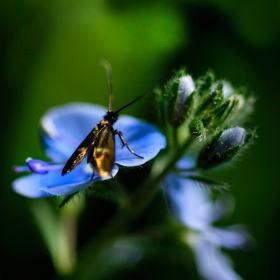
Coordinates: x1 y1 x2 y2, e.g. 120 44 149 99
163 159 250 280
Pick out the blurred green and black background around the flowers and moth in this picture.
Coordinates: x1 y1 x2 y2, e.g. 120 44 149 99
0 0 280 279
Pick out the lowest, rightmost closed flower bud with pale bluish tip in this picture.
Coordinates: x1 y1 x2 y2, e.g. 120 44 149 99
197 126 246 169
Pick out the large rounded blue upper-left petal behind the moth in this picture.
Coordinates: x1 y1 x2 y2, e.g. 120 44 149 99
41 103 107 162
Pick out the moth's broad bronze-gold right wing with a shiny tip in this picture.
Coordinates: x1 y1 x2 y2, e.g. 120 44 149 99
87 126 115 177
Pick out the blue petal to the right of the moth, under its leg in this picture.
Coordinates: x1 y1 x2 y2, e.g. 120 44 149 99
114 116 166 166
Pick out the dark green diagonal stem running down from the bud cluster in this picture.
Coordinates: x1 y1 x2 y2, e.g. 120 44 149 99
63 136 196 279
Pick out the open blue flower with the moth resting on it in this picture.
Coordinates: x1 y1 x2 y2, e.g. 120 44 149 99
12 103 166 198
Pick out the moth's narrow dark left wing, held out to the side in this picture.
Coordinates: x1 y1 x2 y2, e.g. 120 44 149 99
62 126 98 175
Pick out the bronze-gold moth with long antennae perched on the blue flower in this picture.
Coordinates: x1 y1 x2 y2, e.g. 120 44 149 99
62 62 143 178
